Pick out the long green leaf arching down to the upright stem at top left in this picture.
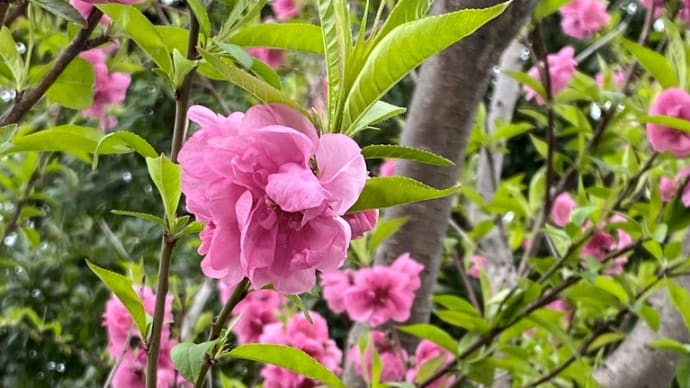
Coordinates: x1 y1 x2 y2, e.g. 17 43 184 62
96 3 172 74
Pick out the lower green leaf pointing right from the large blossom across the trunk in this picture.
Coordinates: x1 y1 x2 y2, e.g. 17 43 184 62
348 176 460 213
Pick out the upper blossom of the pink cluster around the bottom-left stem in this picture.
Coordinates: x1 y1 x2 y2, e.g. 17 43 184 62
103 286 173 358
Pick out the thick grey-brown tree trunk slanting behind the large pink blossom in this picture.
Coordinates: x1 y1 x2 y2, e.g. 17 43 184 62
345 0 536 387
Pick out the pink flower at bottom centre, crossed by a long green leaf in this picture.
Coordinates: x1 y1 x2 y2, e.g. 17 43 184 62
260 311 343 388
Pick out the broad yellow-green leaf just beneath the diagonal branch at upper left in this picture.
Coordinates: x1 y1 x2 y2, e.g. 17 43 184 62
46 58 96 109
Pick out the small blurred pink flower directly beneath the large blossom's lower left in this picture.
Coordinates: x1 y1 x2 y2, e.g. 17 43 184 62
232 290 285 344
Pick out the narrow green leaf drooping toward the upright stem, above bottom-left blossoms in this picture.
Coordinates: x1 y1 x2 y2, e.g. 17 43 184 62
86 260 148 338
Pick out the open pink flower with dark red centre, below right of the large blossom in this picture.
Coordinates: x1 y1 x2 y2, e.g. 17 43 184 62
321 253 424 327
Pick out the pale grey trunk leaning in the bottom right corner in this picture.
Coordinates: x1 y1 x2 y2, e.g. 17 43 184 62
594 232 690 388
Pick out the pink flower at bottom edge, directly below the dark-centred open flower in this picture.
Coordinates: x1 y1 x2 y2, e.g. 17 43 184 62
347 330 407 383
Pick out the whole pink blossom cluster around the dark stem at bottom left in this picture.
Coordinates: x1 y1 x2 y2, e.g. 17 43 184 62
103 286 186 388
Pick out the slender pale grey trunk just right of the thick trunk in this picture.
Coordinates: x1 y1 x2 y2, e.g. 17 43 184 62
467 40 525 294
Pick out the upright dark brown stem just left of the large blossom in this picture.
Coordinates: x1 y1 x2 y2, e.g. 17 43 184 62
146 9 199 388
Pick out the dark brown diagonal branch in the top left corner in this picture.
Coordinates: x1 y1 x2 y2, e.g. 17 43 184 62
0 7 103 127
